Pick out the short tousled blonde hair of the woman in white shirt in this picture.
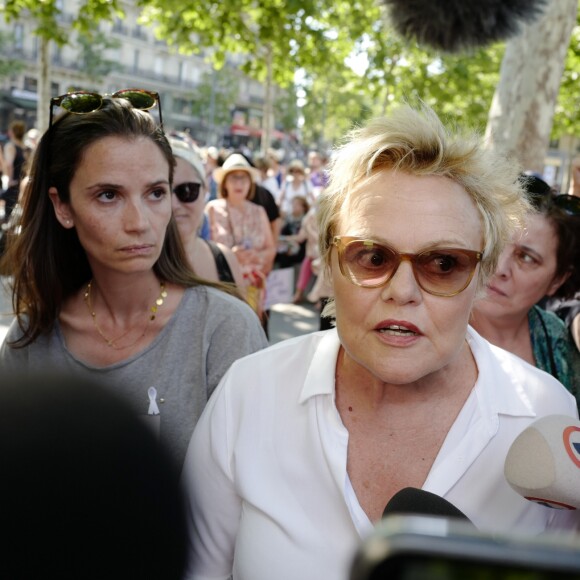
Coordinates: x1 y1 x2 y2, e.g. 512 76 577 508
318 105 530 308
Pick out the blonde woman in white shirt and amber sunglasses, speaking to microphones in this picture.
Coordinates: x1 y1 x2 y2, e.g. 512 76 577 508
184 107 580 580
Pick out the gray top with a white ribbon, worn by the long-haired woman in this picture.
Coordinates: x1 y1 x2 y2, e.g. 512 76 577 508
0 286 268 469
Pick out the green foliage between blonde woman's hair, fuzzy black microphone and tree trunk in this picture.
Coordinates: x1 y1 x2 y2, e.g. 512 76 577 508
303 18 504 150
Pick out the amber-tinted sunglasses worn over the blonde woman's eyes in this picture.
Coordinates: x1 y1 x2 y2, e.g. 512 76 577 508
332 236 483 296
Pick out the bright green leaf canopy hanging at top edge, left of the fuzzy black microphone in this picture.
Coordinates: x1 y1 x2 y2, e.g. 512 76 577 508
138 0 370 87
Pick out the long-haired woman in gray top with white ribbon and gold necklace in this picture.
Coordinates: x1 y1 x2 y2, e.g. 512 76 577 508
0 90 266 468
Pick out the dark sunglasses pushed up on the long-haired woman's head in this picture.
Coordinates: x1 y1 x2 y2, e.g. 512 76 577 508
48 89 163 127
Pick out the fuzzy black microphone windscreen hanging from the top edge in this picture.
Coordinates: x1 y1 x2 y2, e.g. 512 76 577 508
383 0 546 52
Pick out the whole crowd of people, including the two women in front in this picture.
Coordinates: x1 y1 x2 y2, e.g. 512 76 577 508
0 89 580 580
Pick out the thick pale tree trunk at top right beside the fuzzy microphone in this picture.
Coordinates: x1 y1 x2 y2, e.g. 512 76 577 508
486 0 578 172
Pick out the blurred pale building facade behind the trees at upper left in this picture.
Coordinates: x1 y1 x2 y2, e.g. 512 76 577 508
0 0 280 145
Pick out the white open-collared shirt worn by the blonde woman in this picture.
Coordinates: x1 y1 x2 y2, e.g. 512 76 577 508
184 328 579 580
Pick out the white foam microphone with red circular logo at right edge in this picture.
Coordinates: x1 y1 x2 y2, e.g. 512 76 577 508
504 415 580 510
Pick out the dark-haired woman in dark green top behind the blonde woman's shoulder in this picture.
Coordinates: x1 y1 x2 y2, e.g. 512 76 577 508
471 176 580 399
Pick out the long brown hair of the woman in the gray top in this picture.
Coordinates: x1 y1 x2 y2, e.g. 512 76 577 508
0 98 239 347
